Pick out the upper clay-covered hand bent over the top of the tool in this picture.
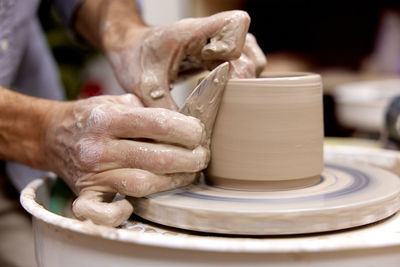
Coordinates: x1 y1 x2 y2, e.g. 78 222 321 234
103 11 266 110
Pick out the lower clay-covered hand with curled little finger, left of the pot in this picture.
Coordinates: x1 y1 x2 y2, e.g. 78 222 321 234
44 94 208 226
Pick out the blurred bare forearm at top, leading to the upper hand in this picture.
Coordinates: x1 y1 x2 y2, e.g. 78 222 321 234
73 0 148 49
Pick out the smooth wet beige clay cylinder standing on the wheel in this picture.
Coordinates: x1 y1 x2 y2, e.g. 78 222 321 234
206 73 324 189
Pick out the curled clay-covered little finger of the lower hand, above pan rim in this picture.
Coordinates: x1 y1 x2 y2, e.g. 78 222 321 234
72 190 133 227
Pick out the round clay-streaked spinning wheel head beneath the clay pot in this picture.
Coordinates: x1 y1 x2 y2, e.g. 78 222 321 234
133 163 400 235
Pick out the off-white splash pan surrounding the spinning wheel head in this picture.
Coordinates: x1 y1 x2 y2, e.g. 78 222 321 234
21 147 400 267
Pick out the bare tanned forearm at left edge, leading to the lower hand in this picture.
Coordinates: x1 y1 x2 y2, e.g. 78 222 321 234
0 86 61 168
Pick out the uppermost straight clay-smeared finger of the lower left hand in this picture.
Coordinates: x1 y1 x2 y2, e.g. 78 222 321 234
109 108 205 148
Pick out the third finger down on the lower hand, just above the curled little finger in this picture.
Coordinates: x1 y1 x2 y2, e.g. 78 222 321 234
81 169 196 197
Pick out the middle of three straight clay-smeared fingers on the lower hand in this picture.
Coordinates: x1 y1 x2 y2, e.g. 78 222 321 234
101 140 209 174
